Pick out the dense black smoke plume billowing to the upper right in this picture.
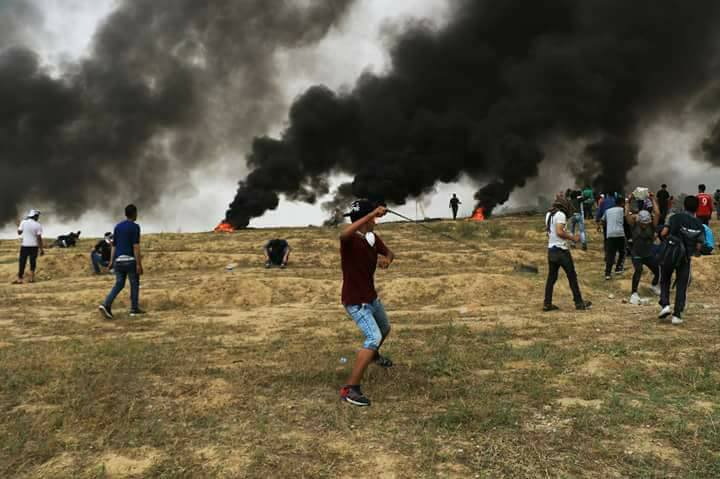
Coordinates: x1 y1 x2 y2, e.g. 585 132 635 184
227 0 720 227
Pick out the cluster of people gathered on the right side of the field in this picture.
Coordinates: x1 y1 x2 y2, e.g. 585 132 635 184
543 185 720 325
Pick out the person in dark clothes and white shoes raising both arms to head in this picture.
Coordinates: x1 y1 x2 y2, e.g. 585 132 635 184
625 193 661 305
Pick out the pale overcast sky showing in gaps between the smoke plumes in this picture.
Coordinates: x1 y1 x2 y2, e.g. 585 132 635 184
0 0 720 238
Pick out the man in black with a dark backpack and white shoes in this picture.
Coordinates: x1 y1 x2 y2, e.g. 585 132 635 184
658 196 705 325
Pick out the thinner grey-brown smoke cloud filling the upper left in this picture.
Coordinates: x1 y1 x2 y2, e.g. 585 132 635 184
0 0 353 223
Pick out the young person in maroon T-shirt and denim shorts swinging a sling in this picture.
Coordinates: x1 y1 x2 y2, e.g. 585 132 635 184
340 200 395 406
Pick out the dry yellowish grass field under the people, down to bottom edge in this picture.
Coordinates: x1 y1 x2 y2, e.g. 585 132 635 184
0 217 720 478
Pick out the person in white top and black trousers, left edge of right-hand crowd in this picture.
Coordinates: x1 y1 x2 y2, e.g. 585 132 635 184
543 198 592 311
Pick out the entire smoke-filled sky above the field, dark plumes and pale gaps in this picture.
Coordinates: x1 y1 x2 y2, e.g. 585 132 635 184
0 0 720 236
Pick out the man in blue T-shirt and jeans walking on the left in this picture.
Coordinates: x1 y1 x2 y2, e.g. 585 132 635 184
98 205 145 319
